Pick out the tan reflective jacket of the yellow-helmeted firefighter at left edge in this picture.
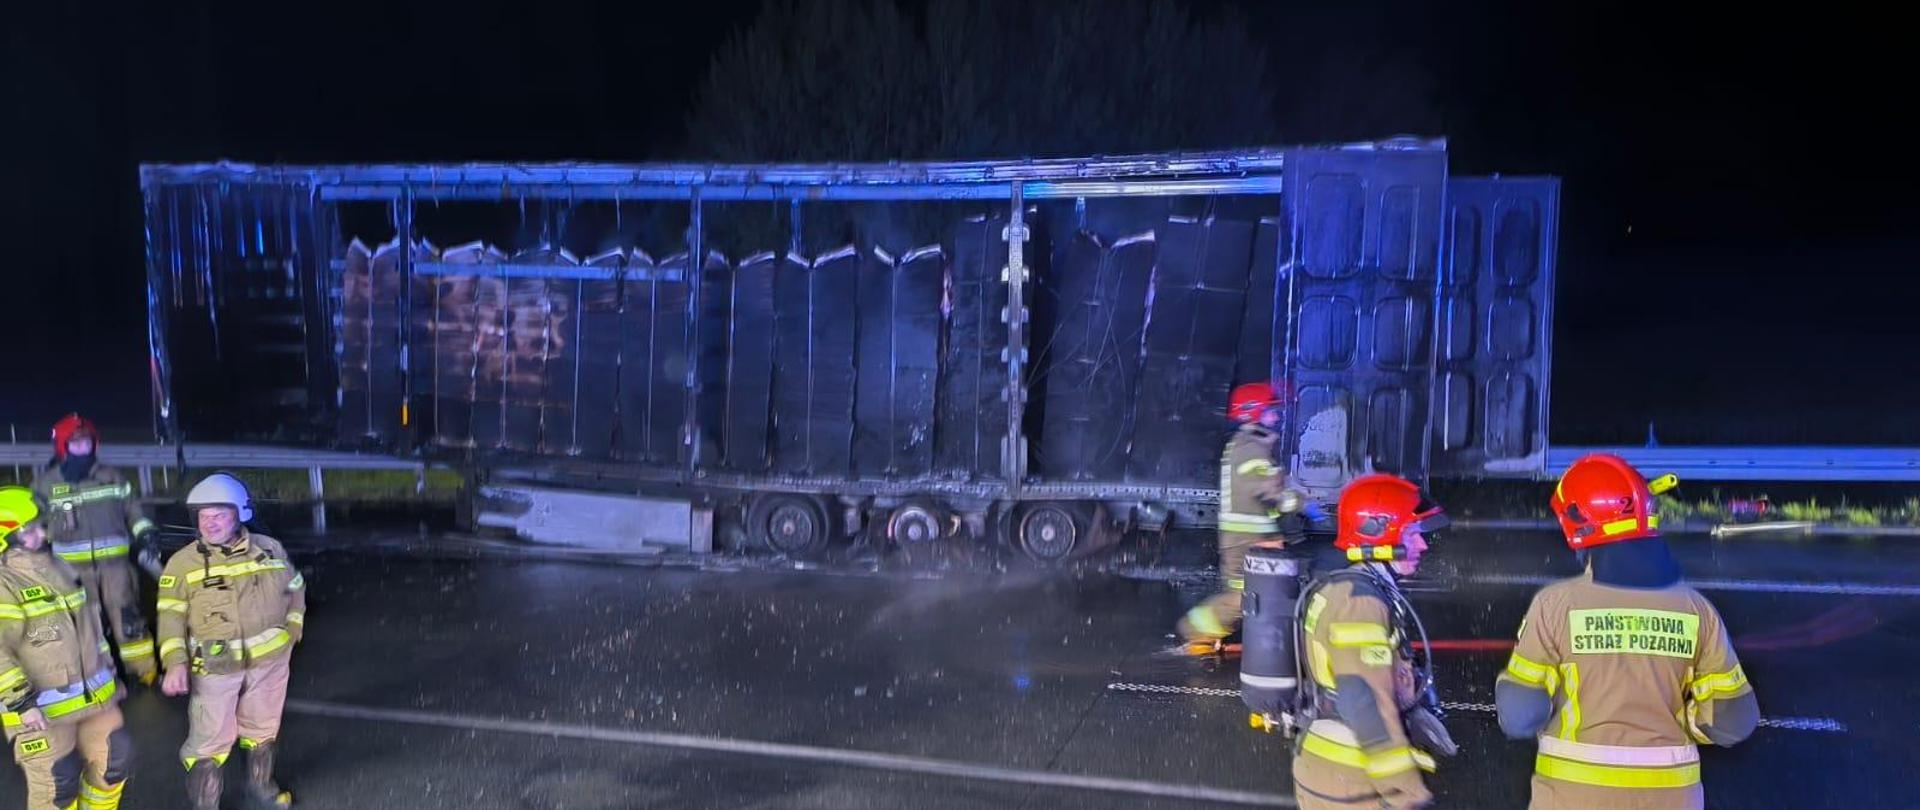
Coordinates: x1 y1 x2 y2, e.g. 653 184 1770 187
0 545 119 740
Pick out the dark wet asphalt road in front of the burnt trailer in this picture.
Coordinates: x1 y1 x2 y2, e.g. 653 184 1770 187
0 534 1920 810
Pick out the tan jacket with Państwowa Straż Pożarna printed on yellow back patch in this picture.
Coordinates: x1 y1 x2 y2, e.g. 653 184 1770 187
1500 572 1759 808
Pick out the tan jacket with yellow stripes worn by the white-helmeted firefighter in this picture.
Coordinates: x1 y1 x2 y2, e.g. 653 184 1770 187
159 530 307 676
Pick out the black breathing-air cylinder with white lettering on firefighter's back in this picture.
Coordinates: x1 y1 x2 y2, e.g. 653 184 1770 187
1240 545 1306 731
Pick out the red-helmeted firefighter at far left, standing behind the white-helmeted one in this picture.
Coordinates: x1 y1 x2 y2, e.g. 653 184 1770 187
33 413 157 685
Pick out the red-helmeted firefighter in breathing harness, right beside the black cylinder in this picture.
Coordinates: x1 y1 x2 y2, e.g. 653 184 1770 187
1294 474 1457 810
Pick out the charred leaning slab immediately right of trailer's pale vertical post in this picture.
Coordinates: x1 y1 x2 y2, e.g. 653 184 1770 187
1033 230 1154 480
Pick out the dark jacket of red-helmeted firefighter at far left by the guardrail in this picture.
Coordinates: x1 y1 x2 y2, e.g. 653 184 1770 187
33 463 154 564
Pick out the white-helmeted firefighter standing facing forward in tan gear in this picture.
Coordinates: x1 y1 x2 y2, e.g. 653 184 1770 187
159 472 307 810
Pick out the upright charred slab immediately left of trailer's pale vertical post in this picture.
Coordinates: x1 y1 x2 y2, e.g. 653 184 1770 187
933 217 1008 478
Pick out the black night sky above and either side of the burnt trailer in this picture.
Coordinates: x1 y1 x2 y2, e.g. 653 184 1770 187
0 0 1920 443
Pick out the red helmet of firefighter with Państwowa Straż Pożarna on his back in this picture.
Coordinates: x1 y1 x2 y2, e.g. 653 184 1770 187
1551 453 1680 549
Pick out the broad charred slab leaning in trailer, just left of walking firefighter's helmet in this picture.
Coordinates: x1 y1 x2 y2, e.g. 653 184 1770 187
1127 219 1254 486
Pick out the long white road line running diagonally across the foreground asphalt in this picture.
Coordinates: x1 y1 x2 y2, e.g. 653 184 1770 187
286 701 1298 808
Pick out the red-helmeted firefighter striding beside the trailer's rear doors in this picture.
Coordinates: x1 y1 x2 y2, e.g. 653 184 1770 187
1177 382 1306 653
